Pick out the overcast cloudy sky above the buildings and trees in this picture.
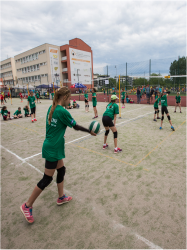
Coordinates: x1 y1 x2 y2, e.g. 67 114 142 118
0 0 187 75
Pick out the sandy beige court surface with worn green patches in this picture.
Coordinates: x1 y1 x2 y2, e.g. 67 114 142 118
0 99 187 250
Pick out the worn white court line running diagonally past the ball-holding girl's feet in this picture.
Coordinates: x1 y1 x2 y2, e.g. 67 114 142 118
0 145 163 250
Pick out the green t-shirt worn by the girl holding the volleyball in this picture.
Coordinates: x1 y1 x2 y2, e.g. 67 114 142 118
42 105 76 162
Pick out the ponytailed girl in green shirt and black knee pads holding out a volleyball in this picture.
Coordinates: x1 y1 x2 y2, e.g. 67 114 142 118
20 86 96 223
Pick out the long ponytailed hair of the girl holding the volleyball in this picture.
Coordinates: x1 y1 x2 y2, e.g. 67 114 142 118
48 86 70 125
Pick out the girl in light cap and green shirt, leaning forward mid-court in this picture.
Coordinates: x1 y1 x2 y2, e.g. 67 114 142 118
102 95 122 154
